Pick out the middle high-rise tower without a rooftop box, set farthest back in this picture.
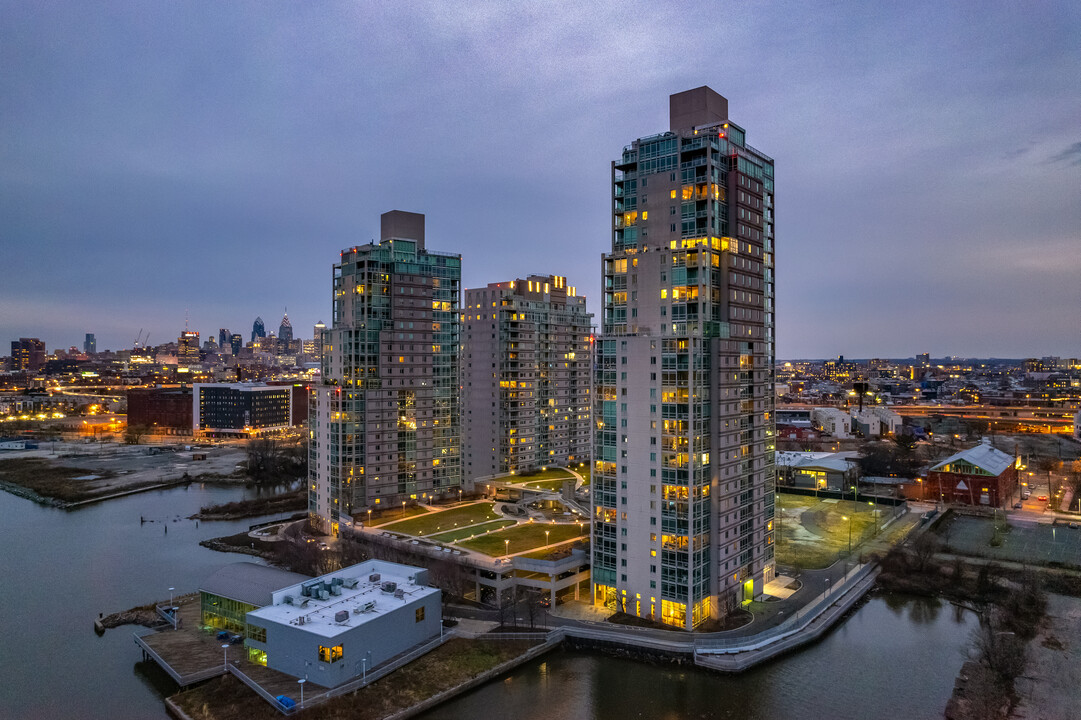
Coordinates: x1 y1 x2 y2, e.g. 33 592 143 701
462 275 592 479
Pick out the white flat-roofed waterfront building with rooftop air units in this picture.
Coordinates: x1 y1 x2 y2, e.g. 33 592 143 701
246 560 441 688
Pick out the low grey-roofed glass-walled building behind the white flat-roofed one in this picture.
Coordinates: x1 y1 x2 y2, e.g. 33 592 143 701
199 562 311 635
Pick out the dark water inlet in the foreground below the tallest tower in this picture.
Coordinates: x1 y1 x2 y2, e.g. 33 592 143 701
421 596 976 720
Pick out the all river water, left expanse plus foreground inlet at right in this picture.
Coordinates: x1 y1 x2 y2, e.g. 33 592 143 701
0 484 975 720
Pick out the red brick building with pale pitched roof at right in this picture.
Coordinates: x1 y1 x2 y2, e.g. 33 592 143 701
924 443 1017 507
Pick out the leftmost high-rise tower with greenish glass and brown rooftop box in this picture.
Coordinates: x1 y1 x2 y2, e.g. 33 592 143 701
308 211 462 534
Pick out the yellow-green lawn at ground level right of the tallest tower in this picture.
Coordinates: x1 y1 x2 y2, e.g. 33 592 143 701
774 493 886 569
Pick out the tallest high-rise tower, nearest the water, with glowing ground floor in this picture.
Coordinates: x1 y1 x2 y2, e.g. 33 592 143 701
592 86 775 629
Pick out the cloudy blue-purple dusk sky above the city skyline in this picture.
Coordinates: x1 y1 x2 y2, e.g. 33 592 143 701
0 0 1081 359
